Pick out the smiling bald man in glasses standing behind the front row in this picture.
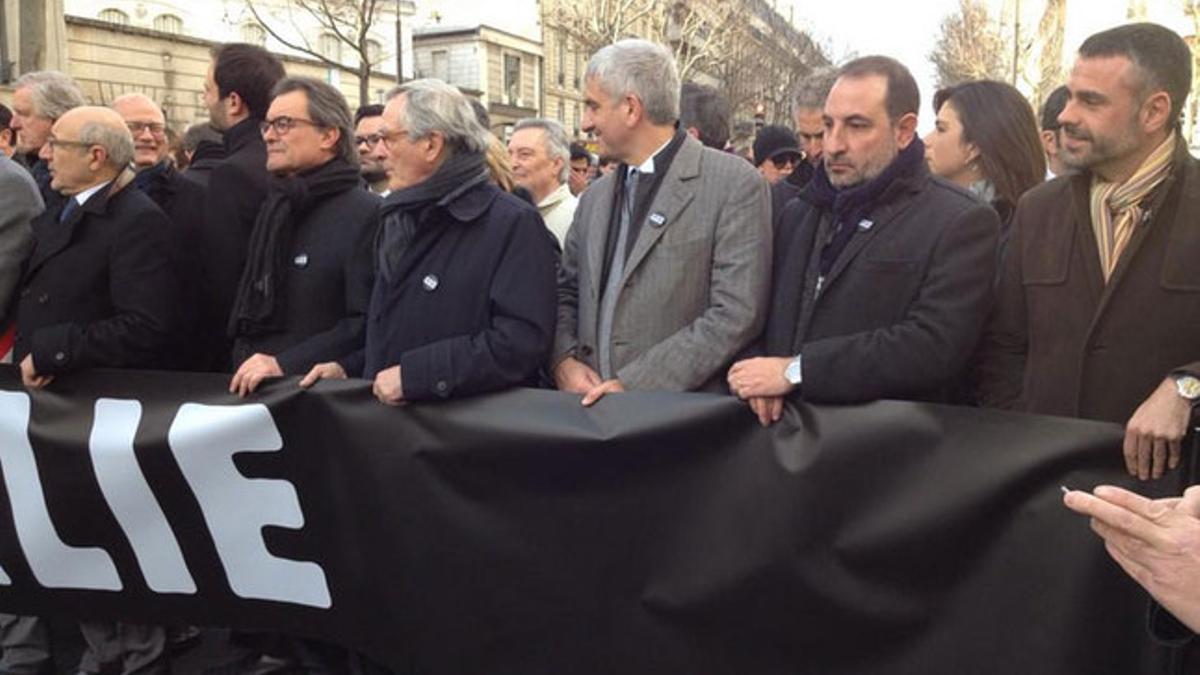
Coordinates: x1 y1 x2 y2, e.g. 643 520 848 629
112 94 208 370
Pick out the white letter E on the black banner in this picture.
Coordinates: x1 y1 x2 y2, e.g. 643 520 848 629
167 404 332 609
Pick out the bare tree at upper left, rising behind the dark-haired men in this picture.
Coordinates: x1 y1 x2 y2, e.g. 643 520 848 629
245 0 384 106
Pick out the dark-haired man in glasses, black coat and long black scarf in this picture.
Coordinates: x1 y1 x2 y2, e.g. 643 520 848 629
229 78 379 395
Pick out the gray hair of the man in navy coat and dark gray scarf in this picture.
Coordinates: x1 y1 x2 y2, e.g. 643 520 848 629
388 78 491 155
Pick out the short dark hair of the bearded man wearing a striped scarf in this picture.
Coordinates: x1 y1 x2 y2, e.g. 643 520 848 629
1079 23 1192 125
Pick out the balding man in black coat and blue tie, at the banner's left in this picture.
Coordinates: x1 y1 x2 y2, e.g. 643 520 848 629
13 107 176 674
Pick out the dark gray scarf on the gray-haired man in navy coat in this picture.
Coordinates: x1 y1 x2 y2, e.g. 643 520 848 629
376 153 488 283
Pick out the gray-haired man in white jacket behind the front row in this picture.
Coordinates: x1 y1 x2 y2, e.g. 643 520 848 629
509 118 580 245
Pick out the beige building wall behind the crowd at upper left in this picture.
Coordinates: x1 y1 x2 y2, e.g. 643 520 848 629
66 17 396 131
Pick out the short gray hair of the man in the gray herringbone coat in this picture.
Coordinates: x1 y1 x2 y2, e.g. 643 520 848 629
586 40 679 125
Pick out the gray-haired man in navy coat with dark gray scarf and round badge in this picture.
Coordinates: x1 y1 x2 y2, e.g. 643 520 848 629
301 79 558 405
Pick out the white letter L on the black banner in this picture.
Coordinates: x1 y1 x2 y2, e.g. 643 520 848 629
0 392 121 591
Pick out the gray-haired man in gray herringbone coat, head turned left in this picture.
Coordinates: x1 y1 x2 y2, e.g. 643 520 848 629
551 40 772 406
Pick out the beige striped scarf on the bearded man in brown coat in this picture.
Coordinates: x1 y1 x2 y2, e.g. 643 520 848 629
1091 133 1175 282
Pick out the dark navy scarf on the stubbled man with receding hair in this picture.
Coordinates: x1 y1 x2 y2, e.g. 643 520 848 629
802 138 925 276
